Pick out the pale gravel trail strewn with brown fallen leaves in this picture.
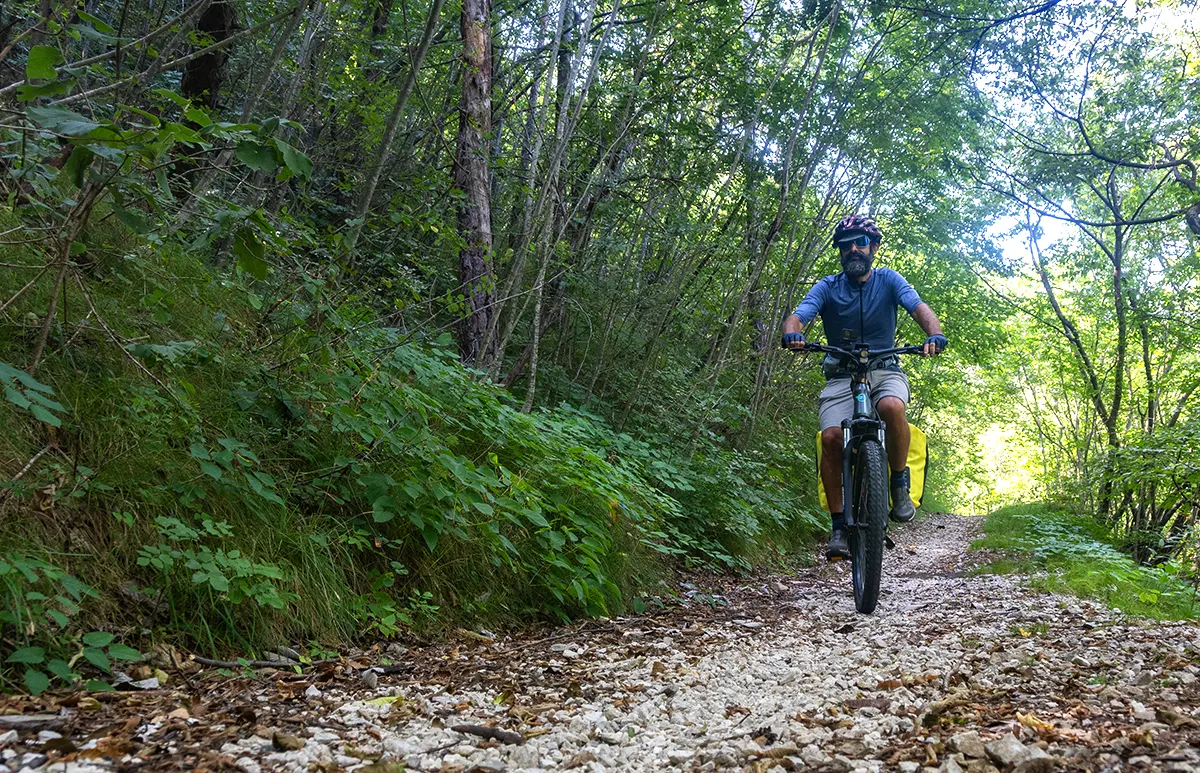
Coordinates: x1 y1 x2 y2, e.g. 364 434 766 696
2 514 1200 773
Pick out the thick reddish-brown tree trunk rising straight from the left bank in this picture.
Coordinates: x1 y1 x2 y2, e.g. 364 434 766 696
454 0 496 368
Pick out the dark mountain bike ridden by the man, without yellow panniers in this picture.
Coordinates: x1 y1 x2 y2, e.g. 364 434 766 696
797 343 924 615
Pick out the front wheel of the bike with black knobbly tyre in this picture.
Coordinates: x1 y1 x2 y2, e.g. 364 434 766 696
850 439 888 615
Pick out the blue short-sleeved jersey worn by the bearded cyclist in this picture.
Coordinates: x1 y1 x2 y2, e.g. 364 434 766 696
796 268 920 349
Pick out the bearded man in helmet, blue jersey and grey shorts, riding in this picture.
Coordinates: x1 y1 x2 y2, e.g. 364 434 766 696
782 215 949 558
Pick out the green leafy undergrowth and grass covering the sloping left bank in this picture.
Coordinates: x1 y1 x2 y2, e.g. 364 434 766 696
0 227 821 685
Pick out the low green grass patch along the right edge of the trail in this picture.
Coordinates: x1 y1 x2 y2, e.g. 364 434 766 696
971 504 1200 619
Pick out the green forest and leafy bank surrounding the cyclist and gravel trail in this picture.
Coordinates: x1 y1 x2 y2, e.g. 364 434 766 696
0 0 1200 693
